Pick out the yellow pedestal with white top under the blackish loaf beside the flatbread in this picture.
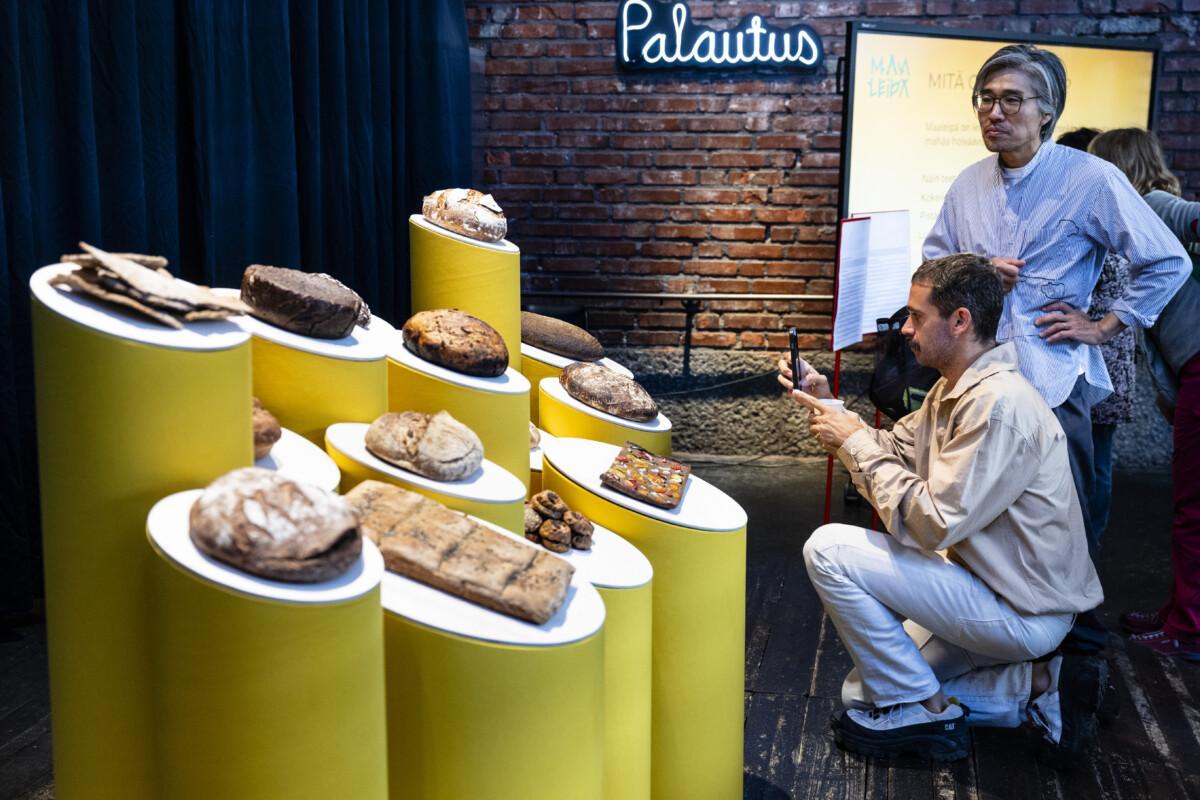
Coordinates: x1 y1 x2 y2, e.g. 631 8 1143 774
239 317 395 447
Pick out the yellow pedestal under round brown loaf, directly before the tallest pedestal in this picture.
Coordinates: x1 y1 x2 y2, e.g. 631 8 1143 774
388 333 529 486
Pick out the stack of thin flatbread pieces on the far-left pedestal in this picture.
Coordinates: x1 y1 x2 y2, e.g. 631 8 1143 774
50 242 250 329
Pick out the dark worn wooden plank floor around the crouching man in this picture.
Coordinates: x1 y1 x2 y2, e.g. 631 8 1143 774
0 462 1200 800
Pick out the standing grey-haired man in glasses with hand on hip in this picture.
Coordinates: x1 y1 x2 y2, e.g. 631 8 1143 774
924 44 1192 563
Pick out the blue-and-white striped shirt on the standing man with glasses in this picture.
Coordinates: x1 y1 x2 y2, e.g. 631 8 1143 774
923 142 1192 408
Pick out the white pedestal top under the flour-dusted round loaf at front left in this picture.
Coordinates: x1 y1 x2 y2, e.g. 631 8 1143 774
146 489 383 606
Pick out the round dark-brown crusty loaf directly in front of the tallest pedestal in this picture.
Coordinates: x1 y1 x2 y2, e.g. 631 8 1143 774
403 308 509 378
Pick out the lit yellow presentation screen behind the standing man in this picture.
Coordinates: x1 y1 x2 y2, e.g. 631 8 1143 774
846 31 1154 270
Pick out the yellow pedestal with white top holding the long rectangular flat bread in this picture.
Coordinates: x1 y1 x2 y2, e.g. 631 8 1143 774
383 532 605 800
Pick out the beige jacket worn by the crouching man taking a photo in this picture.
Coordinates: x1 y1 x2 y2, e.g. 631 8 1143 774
838 342 1104 614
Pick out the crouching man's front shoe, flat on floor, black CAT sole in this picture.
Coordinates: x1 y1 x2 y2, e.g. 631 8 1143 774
833 700 971 762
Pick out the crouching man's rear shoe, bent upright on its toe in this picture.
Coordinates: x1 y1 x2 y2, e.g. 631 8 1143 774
1028 654 1109 769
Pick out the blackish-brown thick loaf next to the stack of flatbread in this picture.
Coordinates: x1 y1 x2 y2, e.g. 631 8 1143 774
234 264 371 339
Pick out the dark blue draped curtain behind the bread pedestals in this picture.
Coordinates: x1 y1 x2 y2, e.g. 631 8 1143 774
0 0 470 613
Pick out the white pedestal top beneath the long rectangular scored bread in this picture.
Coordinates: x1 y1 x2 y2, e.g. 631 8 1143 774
383 517 605 648
